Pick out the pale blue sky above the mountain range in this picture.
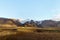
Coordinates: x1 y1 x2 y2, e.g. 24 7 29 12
0 0 60 20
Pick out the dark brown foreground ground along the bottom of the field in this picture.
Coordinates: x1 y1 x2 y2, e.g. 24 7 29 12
0 32 60 40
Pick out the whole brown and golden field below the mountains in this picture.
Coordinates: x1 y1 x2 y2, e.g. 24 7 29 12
0 27 60 40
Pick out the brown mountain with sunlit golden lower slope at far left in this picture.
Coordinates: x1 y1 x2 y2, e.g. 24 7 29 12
0 18 20 28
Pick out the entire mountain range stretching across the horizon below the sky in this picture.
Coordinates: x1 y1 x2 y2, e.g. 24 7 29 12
0 18 60 28
